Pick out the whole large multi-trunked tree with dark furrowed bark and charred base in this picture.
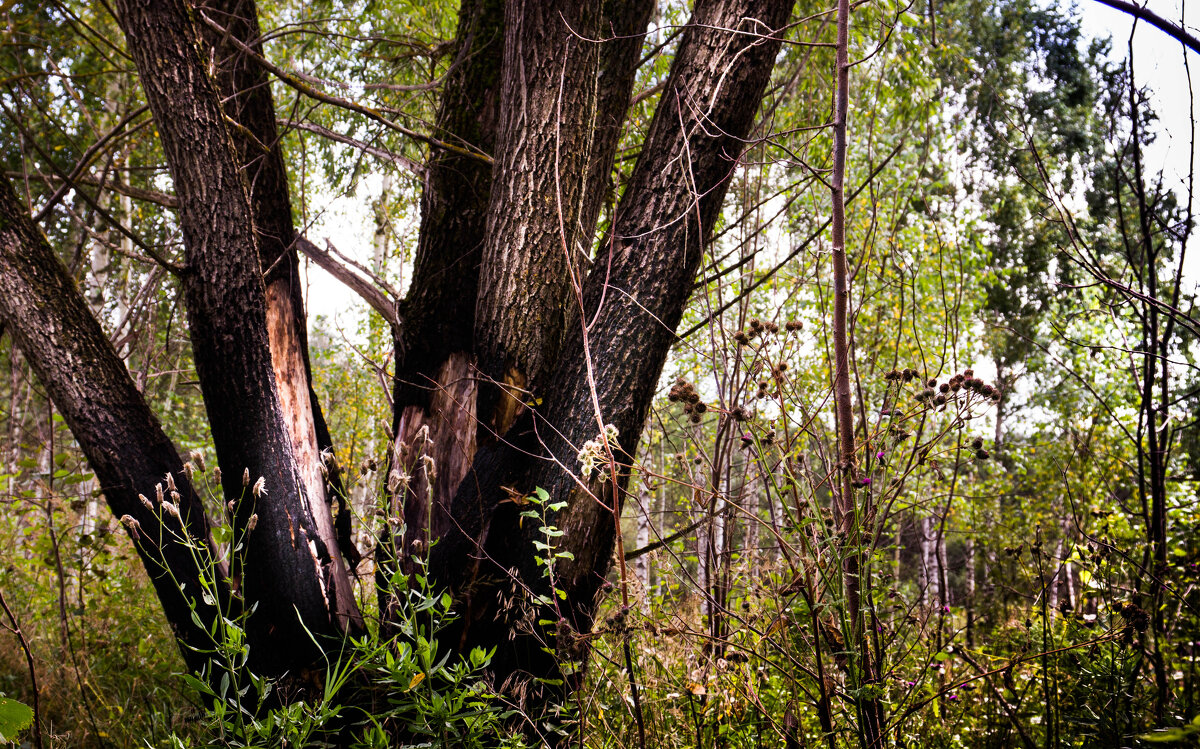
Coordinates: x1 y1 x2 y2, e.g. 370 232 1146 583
0 0 793 705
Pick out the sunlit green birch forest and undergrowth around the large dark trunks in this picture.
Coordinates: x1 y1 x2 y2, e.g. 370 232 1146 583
0 0 1200 749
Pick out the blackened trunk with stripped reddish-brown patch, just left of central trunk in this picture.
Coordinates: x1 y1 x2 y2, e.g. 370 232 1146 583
376 0 504 597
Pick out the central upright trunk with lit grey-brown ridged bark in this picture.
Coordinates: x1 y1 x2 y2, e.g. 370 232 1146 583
475 0 600 435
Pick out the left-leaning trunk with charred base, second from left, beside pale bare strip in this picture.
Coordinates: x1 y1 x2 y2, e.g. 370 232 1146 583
116 0 356 675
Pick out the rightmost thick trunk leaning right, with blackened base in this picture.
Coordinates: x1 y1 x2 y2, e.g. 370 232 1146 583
431 0 792 696
